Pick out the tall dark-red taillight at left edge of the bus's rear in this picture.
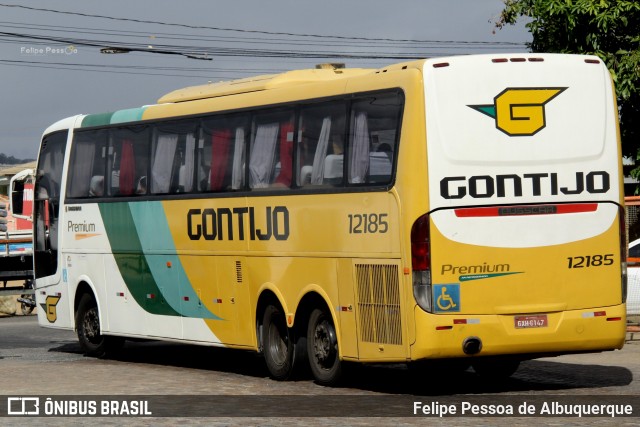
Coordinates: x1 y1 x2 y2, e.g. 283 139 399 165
411 215 431 312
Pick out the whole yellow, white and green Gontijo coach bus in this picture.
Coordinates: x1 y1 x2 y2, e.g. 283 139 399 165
34 54 626 384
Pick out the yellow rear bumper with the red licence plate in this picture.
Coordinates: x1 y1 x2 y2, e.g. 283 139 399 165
411 304 626 360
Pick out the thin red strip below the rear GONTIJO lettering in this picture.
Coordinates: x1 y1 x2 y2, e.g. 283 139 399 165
455 203 598 218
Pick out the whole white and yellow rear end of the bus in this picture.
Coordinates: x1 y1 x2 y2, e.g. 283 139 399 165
412 55 626 359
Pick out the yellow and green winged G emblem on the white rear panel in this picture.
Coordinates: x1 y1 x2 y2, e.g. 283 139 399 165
468 87 567 136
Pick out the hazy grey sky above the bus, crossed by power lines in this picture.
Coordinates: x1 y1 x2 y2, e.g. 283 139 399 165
0 0 531 159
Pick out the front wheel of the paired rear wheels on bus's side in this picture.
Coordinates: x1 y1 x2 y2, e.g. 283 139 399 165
262 305 295 381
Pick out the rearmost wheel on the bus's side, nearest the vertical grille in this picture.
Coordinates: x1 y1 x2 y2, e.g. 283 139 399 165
307 308 342 385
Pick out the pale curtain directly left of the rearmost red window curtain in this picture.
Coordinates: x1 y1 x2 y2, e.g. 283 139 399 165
249 123 279 188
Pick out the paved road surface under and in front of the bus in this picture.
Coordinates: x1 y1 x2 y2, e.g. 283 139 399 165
0 316 640 426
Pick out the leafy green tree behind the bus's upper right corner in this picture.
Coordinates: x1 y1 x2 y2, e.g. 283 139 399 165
495 0 640 167
